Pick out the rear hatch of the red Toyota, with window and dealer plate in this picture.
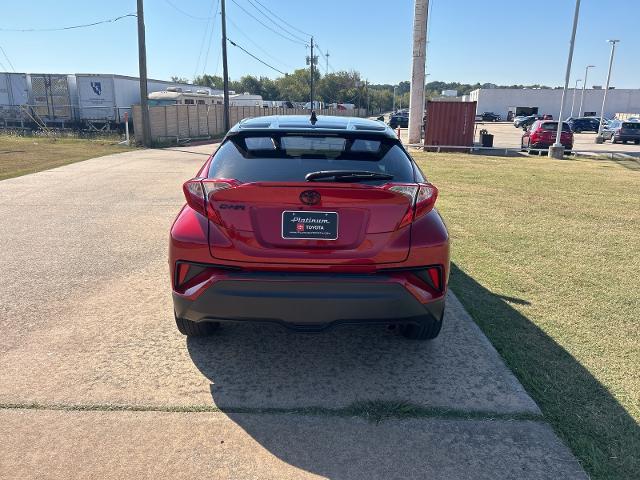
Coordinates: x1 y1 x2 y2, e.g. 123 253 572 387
202 134 415 265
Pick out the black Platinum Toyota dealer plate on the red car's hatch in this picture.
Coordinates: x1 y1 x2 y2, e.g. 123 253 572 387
282 210 338 240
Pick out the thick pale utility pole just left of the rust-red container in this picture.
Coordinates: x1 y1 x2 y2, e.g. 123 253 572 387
409 0 429 143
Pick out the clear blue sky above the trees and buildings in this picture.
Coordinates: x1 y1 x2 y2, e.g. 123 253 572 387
0 0 640 88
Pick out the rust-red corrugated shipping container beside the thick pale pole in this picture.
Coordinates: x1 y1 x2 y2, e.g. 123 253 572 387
424 101 476 147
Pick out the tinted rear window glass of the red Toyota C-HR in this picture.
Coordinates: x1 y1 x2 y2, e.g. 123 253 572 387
208 134 416 185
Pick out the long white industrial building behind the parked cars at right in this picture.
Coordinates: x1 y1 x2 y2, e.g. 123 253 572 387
463 88 640 118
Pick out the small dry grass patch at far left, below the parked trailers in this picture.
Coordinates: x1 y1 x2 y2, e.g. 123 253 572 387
0 135 132 180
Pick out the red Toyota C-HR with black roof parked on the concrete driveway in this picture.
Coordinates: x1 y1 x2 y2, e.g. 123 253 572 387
169 115 449 339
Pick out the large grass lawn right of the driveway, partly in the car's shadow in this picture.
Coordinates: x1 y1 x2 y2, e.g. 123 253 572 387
414 153 640 479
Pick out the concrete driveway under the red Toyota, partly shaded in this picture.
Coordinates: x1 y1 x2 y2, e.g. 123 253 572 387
0 146 586 479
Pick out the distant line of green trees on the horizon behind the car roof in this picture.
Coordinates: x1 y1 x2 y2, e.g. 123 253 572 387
171 68 550 113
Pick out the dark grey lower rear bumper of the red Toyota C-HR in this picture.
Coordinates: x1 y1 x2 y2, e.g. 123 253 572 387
173 272 444 331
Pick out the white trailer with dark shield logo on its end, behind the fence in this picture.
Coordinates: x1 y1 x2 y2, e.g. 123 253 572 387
76 73 197 125
